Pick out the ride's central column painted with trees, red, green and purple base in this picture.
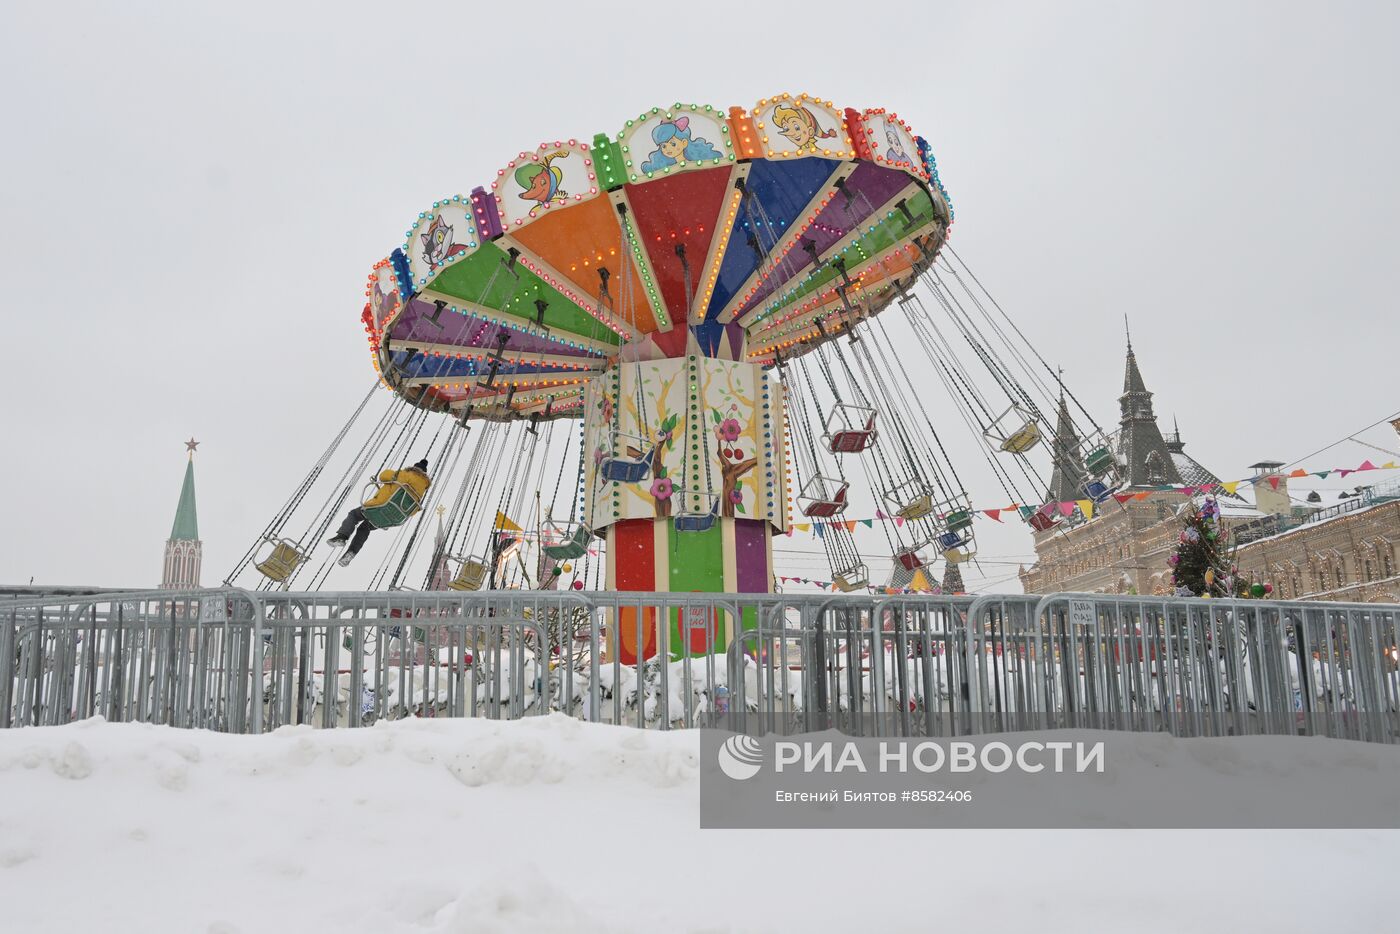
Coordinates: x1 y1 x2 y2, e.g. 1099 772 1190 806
585 343 788 661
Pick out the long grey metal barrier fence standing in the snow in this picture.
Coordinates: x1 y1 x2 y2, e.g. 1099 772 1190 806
0 590 1400 742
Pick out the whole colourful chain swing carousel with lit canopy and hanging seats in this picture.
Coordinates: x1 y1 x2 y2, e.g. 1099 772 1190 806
228 94 1119 658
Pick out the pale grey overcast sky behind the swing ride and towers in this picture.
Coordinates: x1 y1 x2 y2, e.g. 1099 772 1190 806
0 0 1400 587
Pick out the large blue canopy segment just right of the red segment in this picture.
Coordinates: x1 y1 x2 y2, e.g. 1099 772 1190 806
706 158 841 321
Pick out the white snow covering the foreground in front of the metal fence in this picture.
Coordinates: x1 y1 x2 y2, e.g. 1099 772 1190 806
0 716 1400 934
